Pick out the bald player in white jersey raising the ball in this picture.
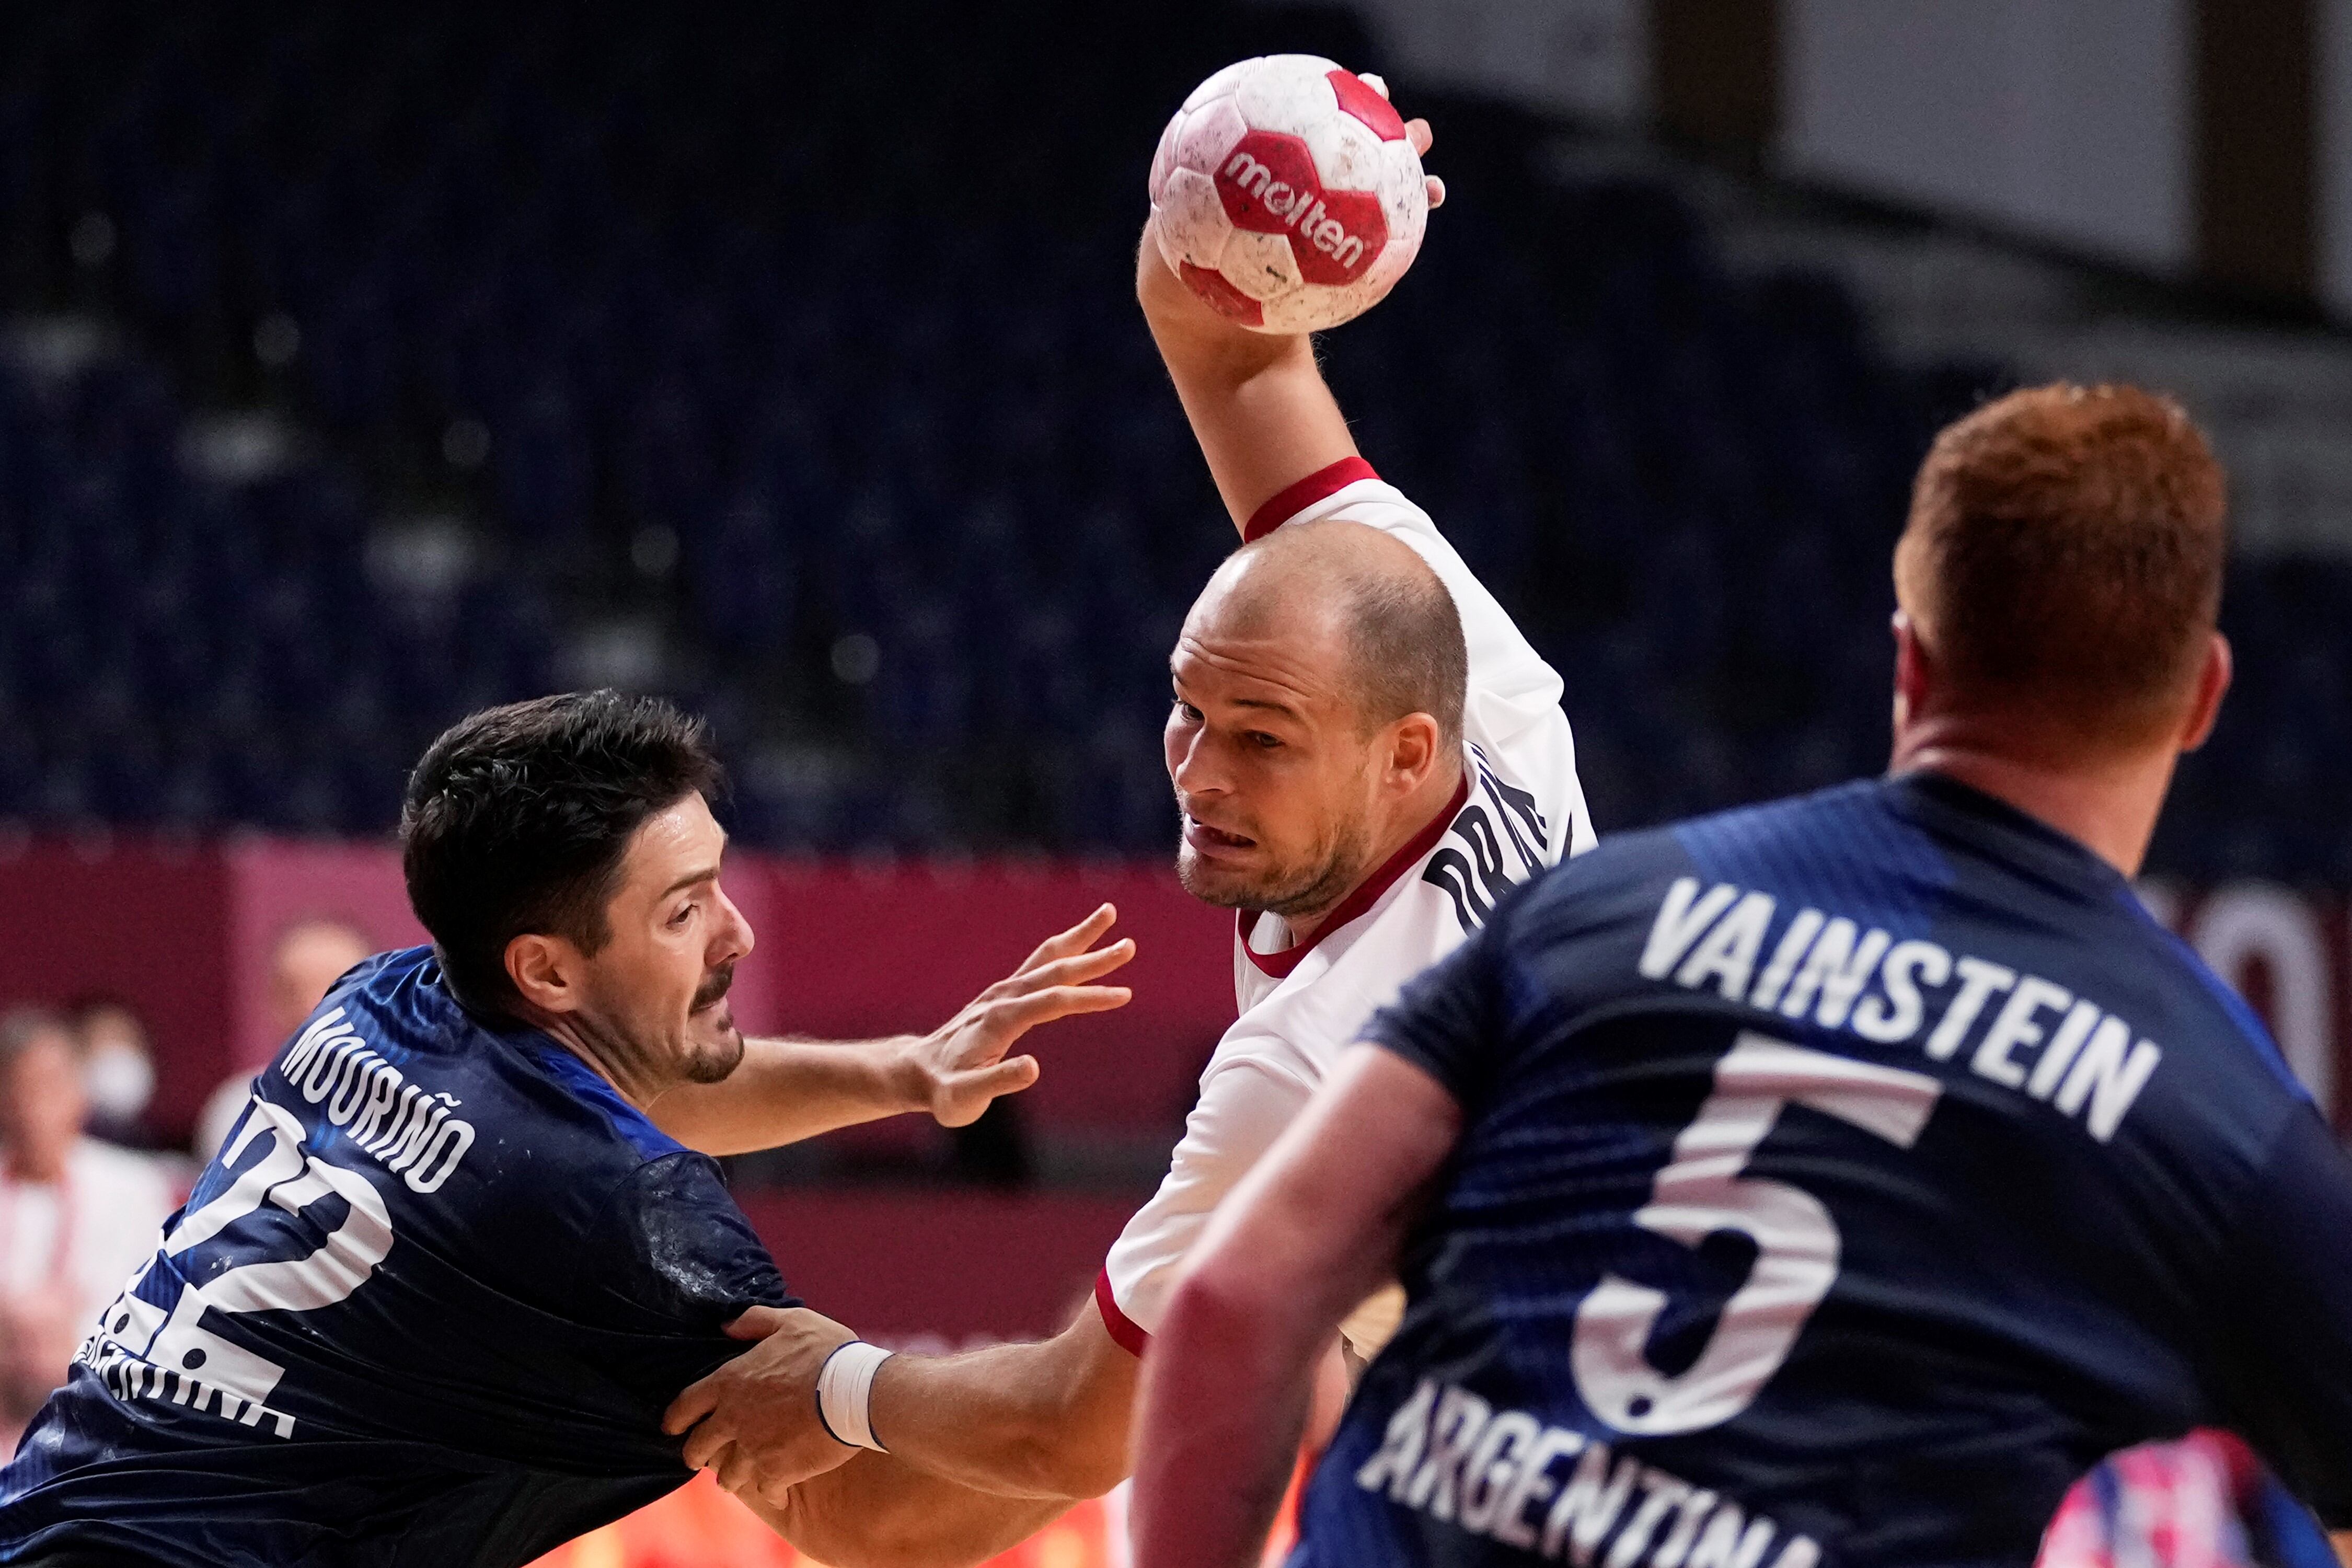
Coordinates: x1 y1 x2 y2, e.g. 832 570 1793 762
671 104 1593 1568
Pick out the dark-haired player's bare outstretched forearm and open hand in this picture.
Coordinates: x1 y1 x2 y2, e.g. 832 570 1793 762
649 905 1136 1154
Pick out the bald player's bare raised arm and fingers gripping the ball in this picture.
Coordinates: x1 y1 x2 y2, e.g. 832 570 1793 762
1136 120 1444 526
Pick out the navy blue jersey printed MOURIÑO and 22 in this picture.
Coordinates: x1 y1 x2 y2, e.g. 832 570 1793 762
0 948 798 1568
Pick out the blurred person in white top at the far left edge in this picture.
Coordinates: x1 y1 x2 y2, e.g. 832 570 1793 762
0 1009 172 1444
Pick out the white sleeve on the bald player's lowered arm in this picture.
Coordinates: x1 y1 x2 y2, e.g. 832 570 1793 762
1094 1055 1315 1354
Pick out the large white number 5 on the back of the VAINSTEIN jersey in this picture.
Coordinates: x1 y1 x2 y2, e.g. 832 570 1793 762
1569 1032 1943 1434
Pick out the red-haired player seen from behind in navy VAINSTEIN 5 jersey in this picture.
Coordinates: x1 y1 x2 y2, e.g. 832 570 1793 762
1134 386 2352 1568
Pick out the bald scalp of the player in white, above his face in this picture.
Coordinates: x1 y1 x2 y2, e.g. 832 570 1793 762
1190 517 1470 745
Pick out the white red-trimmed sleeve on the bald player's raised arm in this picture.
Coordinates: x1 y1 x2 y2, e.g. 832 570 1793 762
1242 458 1593 860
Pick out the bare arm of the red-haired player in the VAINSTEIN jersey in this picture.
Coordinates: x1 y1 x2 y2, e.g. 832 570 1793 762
1134 1046 1461 1568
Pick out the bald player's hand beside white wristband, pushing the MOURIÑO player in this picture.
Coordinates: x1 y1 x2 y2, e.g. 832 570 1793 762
661 1307 856 1502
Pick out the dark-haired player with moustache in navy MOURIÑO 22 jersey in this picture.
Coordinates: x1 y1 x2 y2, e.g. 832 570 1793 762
0 691 1129 1568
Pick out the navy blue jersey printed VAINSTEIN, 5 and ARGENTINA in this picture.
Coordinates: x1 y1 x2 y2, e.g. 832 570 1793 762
1294 776 2352 1568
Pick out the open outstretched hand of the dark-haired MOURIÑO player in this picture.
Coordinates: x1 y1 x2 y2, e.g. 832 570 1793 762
910 903 1136 1126
